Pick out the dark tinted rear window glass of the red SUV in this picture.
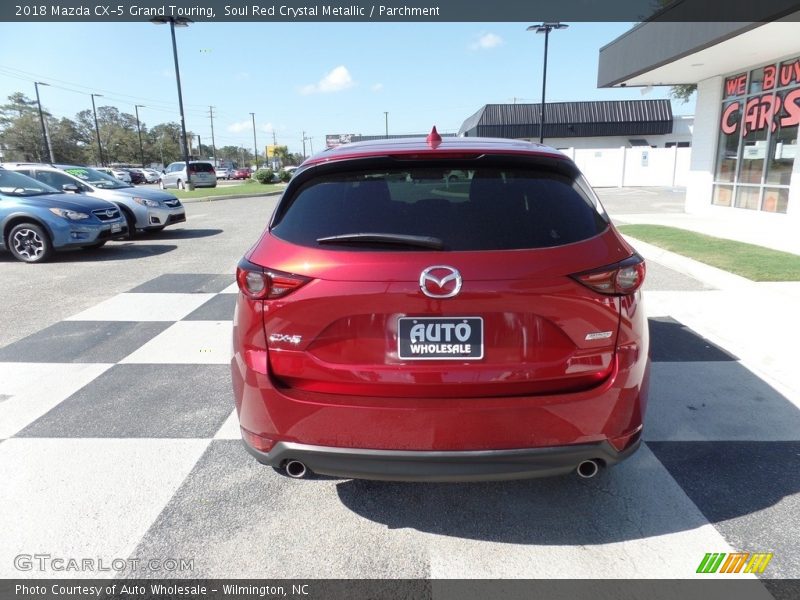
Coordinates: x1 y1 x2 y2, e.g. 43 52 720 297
272 168 608 250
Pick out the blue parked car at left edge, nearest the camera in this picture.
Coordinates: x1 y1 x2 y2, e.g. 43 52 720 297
0 168 127 263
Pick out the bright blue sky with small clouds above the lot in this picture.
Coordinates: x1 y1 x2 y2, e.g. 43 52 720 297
0 22 693 152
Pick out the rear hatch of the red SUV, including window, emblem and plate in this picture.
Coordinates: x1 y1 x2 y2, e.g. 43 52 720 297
248 158 632 398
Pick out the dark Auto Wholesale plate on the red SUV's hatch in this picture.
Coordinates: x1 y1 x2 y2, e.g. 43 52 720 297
397 317 483 360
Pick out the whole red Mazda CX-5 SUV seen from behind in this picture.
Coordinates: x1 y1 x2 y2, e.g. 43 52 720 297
231 129 649 481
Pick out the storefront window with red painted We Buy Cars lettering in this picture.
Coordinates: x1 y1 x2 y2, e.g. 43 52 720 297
711 57 800 213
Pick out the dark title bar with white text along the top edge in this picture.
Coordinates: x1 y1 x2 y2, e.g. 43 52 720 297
0 0 800 23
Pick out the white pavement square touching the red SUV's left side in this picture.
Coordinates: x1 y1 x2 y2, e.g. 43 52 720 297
120 321 233 365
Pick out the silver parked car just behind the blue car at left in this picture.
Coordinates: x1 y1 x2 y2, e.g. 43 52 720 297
3 163 186 237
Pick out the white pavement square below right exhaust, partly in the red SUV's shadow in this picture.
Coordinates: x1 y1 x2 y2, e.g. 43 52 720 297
428 447 756 580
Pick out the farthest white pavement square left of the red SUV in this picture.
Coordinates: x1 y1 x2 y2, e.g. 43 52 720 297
66 294 215 321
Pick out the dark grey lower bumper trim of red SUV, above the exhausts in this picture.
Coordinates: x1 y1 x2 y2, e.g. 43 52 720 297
244 439 641 481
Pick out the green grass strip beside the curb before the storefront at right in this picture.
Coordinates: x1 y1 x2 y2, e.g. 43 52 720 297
618 225 800 281
